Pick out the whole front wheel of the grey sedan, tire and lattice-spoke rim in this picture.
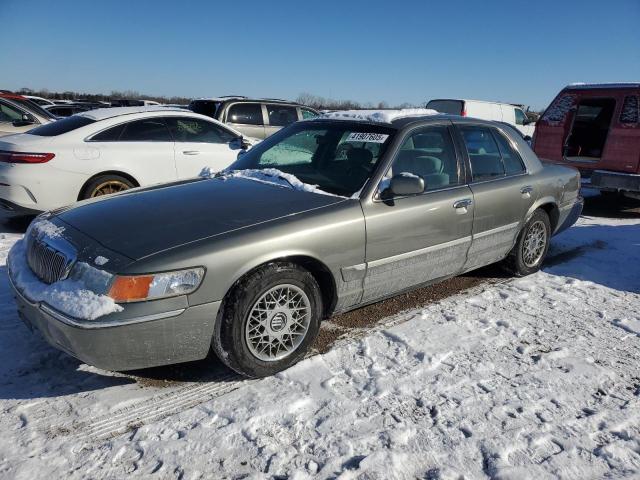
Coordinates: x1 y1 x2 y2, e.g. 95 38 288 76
212 262 322 377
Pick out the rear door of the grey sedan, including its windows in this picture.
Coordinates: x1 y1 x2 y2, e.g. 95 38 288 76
456 123 537 270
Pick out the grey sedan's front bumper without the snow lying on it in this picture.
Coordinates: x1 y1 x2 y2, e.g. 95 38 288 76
9 275 221 371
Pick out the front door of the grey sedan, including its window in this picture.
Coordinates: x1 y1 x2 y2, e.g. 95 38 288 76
363 122 474 302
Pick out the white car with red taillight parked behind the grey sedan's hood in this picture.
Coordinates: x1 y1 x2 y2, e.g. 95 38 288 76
0 107 257 213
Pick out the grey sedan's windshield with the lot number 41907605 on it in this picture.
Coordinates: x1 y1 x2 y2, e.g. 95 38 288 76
229 120 396 197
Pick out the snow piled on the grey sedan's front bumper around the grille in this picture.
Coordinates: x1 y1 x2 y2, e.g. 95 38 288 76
7 239 122 320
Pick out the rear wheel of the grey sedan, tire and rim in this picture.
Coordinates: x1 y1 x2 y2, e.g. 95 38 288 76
504 209 551 277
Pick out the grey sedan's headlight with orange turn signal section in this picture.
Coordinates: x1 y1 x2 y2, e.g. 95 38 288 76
108 267 204 303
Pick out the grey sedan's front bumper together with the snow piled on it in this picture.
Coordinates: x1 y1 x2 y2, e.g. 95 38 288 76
8 241 220 371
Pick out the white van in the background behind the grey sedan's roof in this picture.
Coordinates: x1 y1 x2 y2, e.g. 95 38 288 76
427 98 535 140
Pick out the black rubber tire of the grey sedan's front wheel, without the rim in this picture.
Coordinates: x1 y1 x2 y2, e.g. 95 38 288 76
211 262 322 378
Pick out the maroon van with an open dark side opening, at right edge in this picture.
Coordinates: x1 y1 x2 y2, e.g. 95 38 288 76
533 83 640 199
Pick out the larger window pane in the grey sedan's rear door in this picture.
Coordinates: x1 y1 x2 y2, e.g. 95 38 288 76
459 126 505 182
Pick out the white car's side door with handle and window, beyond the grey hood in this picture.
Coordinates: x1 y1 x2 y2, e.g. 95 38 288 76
166 117 240 178
